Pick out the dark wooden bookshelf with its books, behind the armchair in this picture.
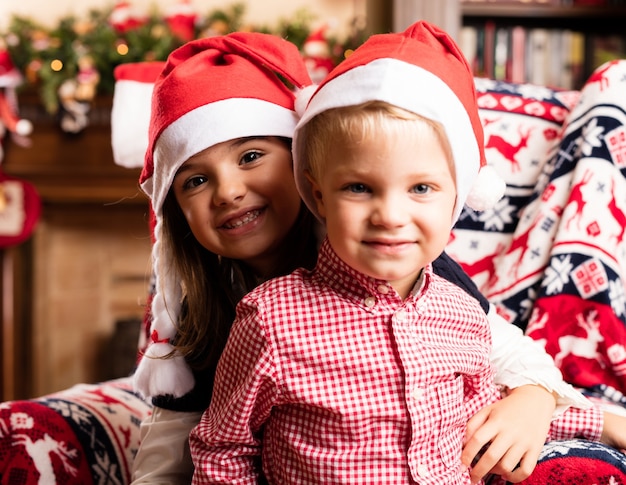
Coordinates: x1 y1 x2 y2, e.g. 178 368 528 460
458 0 626 89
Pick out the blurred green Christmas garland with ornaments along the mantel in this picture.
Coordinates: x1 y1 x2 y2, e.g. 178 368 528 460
0 0 364 131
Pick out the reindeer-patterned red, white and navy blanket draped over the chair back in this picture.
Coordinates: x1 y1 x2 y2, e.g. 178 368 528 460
448 61 626 406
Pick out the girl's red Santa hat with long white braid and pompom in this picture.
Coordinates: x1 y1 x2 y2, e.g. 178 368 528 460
134 32 311 397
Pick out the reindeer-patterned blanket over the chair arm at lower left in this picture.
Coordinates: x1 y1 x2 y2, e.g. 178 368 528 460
0 378 150 485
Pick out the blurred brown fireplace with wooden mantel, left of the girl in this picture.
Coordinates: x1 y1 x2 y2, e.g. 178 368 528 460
0 95 150 400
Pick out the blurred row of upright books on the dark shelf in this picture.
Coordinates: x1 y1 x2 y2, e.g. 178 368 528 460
459 21 626 89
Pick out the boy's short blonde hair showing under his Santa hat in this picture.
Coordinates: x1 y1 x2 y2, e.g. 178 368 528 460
301 101 456 185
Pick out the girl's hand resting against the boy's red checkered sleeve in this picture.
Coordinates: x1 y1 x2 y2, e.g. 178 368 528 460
461 385 556 483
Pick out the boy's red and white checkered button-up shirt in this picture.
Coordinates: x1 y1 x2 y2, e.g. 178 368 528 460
191 241 499 485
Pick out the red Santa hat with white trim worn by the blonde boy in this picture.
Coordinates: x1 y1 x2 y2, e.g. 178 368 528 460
293 21 505 220
